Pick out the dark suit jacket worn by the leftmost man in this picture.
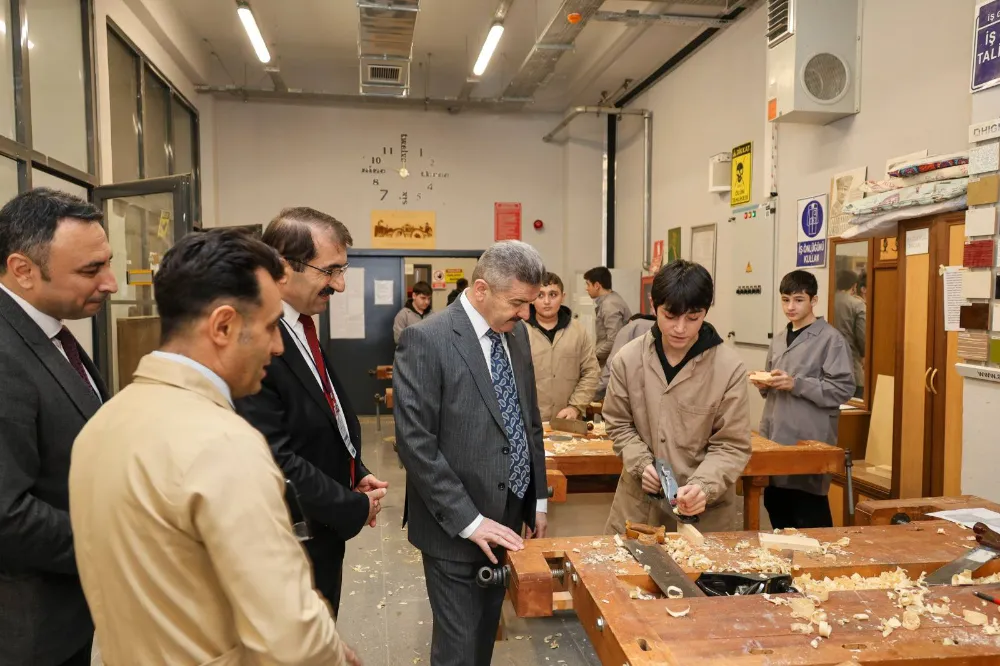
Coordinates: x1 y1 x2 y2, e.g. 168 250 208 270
0 290 108 666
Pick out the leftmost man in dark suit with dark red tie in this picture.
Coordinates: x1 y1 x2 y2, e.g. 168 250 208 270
0 188 118 666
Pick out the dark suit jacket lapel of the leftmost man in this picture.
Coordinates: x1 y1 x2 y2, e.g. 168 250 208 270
0 290 103 419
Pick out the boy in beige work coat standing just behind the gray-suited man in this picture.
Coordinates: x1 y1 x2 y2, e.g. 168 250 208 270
528 273 601 421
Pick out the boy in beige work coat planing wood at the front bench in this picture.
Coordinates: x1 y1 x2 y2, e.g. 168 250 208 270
603 260 750 533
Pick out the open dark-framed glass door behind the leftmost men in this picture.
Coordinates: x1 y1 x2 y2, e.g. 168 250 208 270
93 174 192 394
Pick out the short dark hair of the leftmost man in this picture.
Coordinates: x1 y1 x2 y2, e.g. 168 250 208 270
0 187 104 279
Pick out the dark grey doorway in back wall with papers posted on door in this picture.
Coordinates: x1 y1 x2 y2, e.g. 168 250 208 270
320 250 483 415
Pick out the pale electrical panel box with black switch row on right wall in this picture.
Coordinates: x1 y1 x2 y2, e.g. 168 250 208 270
729 203 778 346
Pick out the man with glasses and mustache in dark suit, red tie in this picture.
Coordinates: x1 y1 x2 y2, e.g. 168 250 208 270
236 208 389 614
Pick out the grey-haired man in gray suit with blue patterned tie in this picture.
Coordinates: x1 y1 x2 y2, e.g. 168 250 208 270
393 241 547 666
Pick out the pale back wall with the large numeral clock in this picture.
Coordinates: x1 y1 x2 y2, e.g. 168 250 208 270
215 100 601 282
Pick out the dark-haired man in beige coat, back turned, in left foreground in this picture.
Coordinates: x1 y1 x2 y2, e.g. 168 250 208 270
69 229 358 666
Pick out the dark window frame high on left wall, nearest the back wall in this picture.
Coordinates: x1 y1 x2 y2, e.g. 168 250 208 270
105 18 201 221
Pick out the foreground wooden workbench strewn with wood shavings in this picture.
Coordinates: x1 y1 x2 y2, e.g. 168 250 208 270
509 500 1000 666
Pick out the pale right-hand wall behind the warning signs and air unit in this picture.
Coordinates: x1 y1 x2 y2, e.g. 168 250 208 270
616 0 976 420
